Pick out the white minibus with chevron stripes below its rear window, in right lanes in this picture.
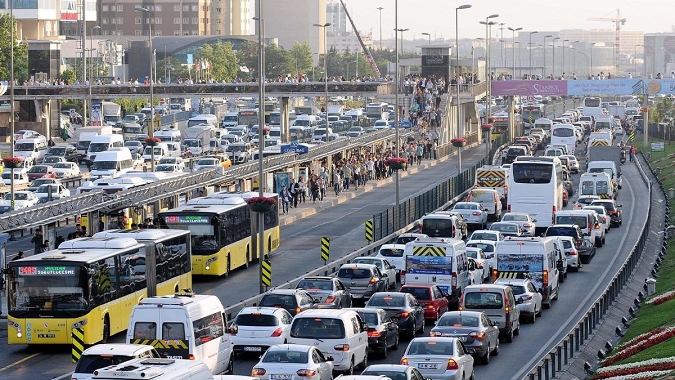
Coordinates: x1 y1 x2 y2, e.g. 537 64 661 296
492 237 560 309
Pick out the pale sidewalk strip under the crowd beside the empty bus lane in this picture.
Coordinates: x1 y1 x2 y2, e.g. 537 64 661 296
279 143 485 227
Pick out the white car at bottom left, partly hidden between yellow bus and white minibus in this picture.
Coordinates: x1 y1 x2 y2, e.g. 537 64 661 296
70 343 161 380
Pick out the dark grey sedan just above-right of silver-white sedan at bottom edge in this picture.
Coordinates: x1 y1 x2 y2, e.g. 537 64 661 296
429 311 499 364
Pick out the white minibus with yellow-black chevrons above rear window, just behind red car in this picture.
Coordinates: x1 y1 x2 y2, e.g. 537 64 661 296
401 237 469 310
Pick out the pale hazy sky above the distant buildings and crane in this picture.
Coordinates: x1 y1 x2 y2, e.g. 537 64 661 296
344 0 675 41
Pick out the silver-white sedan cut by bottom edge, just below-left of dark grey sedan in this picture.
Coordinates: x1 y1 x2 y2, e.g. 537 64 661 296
401 337 474 380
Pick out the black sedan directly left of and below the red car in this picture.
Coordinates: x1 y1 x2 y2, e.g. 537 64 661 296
366 292 424 338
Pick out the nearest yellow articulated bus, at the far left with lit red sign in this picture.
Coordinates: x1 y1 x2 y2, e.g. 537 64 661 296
7 230 192 345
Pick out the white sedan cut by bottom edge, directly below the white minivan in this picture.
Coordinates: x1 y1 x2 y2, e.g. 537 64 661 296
251 344 333 380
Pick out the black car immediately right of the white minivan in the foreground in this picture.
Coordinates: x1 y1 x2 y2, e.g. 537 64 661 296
352 308 399 358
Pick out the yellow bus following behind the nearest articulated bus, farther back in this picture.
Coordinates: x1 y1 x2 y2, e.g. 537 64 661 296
159 192 281 276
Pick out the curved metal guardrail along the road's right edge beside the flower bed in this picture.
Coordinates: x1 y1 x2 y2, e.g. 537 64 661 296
527 152 653 380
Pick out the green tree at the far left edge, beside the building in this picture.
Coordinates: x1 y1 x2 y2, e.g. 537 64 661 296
0 14 28 83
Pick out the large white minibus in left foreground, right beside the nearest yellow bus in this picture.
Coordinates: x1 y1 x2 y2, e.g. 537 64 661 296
126 295 235 374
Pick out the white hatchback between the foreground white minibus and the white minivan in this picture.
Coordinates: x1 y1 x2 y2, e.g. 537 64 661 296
230 307 293 353
